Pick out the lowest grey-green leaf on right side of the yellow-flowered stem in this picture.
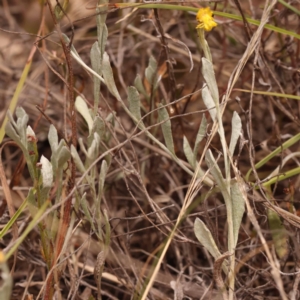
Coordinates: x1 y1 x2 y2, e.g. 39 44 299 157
230 182 245 247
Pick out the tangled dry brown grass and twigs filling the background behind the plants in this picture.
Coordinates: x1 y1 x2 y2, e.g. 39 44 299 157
0 0 300 300
